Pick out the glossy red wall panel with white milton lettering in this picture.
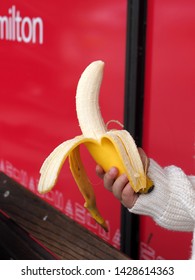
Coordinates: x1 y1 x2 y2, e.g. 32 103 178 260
0 0 126 248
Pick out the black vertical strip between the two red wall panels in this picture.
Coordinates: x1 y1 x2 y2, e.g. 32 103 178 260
121 0 147 259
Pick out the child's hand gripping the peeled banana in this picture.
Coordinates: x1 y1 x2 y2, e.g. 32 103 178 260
96 148 148 208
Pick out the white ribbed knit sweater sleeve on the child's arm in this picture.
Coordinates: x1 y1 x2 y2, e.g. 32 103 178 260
129 159 195 260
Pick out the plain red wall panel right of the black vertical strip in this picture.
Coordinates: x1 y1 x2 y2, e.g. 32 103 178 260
140 0 195 259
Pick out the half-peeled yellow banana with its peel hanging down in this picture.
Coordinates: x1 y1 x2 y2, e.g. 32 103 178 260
38 61 153 231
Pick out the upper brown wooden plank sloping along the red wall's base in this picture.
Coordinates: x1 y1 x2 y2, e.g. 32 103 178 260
0 172 128 260
